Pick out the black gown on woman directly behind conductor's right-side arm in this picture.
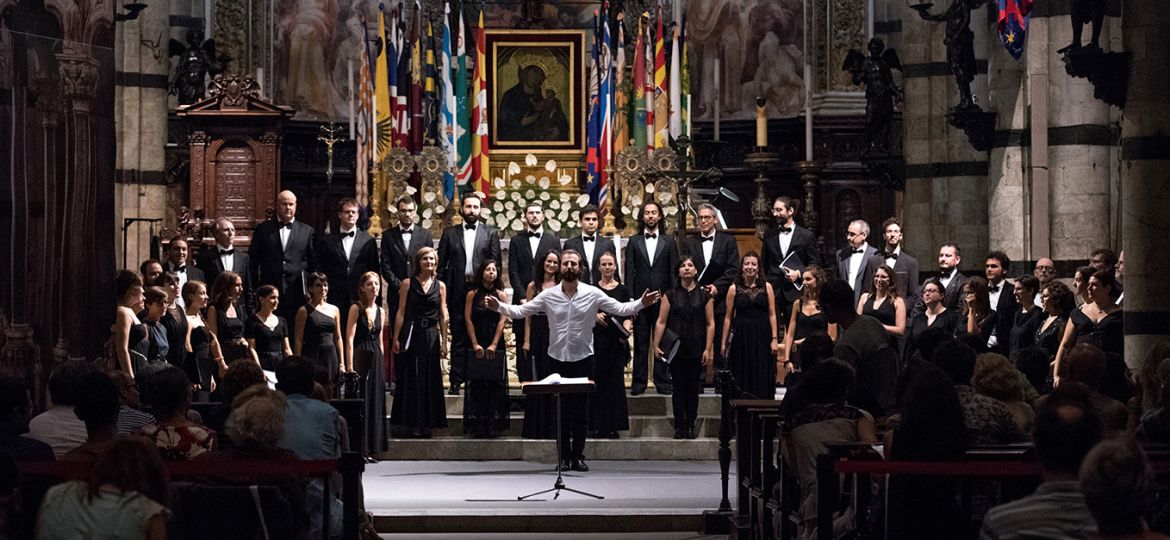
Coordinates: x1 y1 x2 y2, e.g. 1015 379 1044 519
589 283 629 435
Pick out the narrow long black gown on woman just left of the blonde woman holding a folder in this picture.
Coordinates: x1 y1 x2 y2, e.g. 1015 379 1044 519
355 306 388 455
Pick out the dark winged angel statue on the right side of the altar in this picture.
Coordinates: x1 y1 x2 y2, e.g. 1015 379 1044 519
841 37 902 153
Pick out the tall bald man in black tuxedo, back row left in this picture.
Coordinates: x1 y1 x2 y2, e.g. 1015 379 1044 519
248 189 317 320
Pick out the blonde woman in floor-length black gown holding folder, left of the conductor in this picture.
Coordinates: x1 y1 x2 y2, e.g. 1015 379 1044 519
390 247 450 437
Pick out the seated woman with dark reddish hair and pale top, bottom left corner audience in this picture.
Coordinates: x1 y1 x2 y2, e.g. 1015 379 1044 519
36 439 170 540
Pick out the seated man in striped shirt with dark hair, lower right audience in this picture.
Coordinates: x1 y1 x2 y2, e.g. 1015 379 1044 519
979 397 1101 540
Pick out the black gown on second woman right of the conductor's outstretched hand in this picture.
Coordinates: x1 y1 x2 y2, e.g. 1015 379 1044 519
728 285 776 400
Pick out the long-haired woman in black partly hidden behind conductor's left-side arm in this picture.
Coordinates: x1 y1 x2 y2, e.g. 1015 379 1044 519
521 251 560 438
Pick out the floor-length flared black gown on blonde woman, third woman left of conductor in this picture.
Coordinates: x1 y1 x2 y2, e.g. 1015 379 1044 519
390 279 447 431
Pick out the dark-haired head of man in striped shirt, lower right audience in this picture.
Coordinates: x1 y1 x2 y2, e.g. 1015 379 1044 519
1032 397 1102 476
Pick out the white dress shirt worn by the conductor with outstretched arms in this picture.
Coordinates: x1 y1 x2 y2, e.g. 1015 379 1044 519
500 282 642 362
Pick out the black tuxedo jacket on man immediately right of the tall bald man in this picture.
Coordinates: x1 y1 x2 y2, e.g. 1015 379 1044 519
317 230 380 313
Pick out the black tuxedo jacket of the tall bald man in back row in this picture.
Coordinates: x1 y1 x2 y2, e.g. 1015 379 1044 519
248 220 317 306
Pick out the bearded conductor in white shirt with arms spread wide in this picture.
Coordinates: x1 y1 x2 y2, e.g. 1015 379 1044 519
483 249 661 472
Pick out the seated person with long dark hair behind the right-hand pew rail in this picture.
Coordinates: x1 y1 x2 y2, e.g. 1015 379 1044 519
886 366 968 539
